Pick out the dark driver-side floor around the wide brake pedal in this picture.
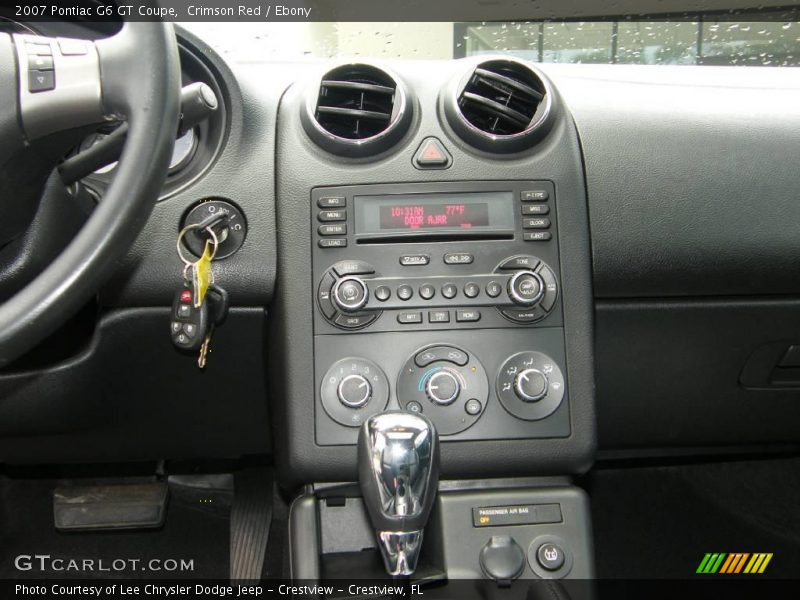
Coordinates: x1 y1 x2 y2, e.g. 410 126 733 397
0 477 232 579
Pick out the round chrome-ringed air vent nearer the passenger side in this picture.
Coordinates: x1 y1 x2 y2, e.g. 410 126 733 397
445 58 552 152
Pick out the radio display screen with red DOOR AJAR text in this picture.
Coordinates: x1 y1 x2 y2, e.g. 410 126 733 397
354 192 514 237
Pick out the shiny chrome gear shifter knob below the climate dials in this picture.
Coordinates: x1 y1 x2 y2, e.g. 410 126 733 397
358 412 439 576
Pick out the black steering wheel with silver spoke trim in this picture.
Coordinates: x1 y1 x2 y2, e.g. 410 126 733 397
0 22 181 367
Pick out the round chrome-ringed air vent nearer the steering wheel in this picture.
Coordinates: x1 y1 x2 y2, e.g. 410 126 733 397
303 64 411 157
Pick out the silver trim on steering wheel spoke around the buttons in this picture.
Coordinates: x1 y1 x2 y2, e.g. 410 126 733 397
13 34 105 140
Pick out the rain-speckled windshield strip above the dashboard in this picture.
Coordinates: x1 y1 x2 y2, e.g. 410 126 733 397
182 14 800 67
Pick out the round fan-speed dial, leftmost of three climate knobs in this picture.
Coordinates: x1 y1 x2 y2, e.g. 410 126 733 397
320 358 389 427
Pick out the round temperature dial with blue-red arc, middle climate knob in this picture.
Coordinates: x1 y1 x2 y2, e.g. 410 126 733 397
396 344 489 436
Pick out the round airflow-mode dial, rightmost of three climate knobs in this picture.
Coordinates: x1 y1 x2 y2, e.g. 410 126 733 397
495 352 566 421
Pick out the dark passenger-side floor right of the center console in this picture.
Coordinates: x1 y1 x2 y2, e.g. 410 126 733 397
582 458 800 578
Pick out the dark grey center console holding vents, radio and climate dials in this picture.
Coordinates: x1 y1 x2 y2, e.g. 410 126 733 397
267 59 595 584
